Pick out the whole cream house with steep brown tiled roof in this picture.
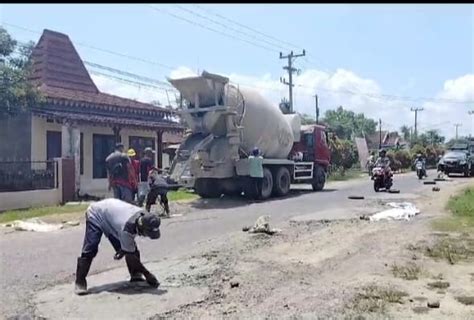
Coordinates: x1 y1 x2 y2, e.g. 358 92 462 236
0 30 183 195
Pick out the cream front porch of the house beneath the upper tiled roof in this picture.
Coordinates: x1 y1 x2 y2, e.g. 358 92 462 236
31 112 180 197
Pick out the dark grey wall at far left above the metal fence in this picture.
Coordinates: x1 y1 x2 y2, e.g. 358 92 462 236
0 113 31 161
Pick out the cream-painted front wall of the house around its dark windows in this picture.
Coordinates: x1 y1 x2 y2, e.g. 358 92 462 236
30 117 170 197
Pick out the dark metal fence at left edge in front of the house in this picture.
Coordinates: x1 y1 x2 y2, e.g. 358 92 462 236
0 160 59 192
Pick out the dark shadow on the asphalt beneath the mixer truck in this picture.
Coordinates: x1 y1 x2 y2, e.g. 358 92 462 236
190 189 337 209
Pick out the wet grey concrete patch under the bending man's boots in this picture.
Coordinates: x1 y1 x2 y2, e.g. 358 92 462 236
33 259 214 319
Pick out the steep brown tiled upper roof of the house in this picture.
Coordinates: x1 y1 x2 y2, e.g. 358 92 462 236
30 30 172 115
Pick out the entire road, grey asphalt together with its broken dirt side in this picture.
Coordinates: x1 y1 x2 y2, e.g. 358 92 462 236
0 174 474 319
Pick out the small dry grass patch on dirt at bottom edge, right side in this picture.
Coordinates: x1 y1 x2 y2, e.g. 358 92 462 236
346 285 408 314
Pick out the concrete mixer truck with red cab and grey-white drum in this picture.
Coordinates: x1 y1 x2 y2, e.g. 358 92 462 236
168 71 330 199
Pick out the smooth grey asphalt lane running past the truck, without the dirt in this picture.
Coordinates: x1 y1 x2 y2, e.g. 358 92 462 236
0 172 435 316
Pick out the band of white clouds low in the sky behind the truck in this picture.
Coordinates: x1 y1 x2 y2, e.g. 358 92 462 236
93 66 474 138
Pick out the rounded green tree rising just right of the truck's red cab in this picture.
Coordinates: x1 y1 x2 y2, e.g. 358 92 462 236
323 106 377 140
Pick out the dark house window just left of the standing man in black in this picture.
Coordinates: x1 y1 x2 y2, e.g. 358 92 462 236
92 134 115 179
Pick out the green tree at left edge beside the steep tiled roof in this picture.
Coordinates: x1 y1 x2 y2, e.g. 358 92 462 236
0 27 41 117
